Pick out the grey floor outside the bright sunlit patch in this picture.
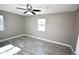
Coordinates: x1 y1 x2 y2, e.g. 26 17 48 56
0 36 73 55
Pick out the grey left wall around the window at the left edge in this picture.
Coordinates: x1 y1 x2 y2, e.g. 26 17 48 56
0 11 25 39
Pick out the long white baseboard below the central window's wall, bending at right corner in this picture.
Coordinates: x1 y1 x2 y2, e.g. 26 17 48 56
26 34 75 54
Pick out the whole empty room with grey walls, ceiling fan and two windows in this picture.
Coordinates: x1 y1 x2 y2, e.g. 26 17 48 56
0 4 79 55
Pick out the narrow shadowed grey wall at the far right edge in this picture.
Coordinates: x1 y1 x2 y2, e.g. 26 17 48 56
71 10 79 50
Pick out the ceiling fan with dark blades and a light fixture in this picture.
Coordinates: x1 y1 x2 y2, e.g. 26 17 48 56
16 4 41 15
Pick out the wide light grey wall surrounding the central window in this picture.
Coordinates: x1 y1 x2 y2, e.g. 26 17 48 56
26 12 76 48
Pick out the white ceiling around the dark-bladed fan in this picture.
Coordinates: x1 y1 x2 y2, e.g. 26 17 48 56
0 4 78 16
